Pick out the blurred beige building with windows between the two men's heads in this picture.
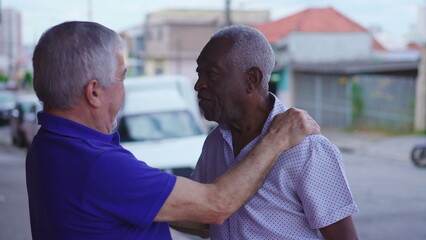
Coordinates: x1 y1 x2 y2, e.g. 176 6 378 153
142 10 269 83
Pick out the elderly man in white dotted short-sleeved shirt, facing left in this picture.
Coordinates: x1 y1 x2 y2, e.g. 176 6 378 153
180 26 357 240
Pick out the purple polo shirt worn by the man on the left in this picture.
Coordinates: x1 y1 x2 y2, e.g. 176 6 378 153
26 112 176 240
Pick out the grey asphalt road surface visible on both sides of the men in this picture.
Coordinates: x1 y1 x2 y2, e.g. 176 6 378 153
0 127 426 240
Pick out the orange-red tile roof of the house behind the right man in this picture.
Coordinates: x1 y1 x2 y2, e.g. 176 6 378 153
254 7 385 50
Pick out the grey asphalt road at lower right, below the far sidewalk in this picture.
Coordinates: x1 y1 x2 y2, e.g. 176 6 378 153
344 154 426 240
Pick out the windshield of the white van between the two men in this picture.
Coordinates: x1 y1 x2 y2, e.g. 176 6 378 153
118 111 202 142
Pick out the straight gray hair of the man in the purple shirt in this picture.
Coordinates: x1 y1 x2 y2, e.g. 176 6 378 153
33 22 123 109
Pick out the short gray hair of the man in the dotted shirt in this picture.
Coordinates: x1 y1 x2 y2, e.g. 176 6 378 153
211 25 275 91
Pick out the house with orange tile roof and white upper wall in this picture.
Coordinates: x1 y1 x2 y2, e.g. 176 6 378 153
255 7 385 106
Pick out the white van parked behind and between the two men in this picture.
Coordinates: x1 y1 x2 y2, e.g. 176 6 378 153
117 76 206 177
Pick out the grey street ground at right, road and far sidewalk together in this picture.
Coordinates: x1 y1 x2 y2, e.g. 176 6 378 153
322 129 426 240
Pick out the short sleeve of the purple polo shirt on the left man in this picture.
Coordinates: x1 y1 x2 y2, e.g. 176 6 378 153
85 150 176 228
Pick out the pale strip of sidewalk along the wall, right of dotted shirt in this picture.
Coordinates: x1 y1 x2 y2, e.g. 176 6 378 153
321 128 426 161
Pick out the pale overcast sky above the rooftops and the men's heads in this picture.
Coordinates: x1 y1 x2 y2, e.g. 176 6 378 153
0 0 426 45
